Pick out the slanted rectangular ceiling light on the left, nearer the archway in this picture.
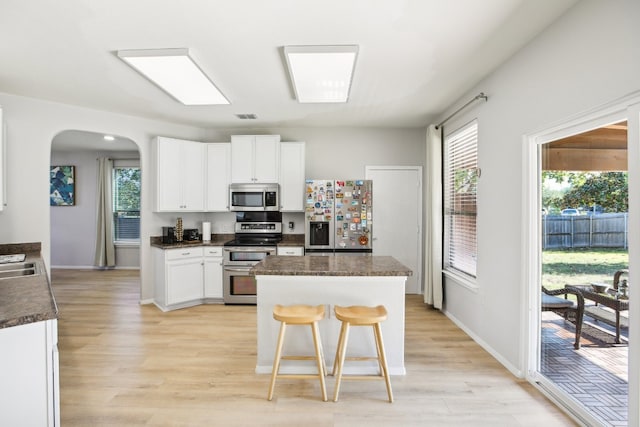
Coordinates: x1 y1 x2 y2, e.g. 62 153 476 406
118 49 229 105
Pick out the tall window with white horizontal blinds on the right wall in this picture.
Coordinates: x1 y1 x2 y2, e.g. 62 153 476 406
443 121 479 277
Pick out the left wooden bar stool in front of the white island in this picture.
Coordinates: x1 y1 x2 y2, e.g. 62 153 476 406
268 304 327 402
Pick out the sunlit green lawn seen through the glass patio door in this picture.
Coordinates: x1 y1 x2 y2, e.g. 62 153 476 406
542 248 629 289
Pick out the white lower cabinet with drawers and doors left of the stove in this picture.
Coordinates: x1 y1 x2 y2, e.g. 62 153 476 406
153 246 222 311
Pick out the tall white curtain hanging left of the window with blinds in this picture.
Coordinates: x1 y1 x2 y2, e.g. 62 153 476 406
424 125 443 309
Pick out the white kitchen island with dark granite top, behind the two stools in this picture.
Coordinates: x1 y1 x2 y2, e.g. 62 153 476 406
250 256 412 375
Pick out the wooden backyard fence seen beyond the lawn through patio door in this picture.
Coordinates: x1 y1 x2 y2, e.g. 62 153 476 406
542 212 628 249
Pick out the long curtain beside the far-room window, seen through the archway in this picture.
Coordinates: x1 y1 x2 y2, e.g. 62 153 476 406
93 157 116 267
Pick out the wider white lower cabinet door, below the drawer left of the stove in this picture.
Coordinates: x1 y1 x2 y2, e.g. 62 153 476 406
167 257 204 305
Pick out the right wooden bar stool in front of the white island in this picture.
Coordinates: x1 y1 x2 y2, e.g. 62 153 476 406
332 305 393 402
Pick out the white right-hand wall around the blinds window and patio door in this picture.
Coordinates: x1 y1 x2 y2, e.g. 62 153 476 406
443 0 640 372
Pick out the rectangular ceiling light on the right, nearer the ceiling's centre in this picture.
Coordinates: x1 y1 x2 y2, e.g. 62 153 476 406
284 45 358 103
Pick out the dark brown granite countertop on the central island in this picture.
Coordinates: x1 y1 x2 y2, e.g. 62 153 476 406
249 255 413 276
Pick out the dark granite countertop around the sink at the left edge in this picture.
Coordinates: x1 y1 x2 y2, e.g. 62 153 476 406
0 243 58 329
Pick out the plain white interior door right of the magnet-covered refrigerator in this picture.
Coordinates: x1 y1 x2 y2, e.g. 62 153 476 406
366 166 422 294
